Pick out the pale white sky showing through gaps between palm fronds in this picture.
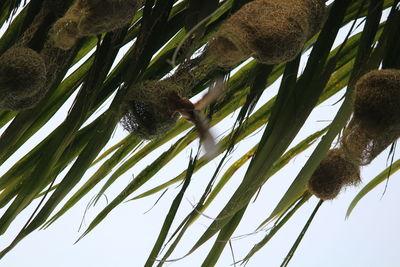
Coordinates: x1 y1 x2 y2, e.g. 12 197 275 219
0 2 400 267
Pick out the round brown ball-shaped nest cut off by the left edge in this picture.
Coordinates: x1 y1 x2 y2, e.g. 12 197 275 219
0 47 46 110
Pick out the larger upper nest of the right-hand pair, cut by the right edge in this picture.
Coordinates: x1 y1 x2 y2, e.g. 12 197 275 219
342 69 400 165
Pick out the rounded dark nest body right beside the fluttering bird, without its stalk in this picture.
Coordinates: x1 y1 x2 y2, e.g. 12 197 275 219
121 79 187 140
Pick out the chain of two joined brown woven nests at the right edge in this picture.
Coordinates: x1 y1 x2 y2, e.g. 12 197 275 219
308 69 400 200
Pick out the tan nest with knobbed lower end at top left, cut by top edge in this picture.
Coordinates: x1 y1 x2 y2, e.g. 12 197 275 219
51 0 139 50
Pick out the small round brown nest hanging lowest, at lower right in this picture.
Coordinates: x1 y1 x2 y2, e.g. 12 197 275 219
308 149 360 200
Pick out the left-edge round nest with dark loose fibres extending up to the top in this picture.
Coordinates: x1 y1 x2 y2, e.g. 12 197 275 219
0 0 75 110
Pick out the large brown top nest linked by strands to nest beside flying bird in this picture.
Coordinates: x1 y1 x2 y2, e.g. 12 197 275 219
122 0 325 139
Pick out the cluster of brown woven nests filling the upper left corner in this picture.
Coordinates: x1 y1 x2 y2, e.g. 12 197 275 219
0 0 138 110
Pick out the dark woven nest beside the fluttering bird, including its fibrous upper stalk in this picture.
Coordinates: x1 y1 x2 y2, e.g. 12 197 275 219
121 57 215 139
